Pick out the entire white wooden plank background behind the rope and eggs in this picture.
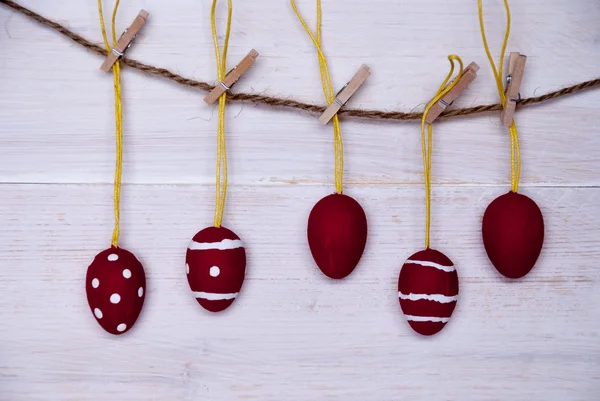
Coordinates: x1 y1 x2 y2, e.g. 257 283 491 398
0 0 600 401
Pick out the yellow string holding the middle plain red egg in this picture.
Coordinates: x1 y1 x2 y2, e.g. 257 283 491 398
290 0 344 194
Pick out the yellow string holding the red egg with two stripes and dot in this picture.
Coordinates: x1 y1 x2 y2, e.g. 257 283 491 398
210 0 233 227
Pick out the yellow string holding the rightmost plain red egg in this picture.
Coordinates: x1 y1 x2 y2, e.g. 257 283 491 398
477 0 521 192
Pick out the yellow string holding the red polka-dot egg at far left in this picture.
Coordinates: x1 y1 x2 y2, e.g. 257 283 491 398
98 0 123 247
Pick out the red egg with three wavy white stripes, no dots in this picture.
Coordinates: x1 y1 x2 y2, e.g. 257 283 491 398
398 248 458 336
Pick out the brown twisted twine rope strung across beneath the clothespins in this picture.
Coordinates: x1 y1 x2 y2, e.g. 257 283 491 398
0 0 600 121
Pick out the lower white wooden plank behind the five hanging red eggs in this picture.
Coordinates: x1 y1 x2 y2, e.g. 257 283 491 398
0 185 600 401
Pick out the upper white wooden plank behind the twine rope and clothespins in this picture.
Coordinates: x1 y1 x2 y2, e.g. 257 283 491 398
0 0 600 186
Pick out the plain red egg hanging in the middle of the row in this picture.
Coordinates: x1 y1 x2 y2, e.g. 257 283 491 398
307 193 367 279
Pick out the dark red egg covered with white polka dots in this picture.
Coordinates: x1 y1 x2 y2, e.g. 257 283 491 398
85 246 146 334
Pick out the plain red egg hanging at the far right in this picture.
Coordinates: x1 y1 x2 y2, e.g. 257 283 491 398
481 191 544 278
